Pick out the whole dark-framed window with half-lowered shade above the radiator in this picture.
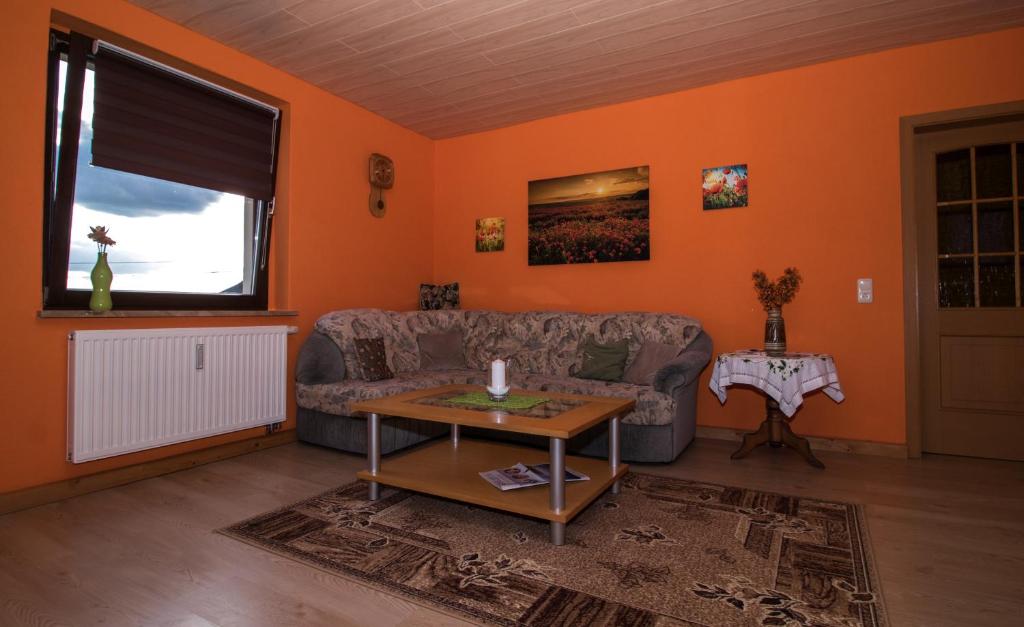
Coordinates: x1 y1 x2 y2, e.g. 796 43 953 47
43 32 280 309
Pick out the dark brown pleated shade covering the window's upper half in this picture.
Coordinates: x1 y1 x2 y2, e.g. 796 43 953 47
92 47 276 201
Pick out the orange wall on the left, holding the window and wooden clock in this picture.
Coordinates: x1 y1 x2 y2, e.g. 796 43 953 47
0 0 433 493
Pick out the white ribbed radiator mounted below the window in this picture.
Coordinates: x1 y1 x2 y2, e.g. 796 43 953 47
68 326 289 463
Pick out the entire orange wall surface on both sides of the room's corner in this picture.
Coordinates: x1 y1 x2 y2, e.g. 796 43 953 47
0 0 1024 493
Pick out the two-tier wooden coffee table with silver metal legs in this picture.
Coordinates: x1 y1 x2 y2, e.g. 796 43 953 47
352 385 635 545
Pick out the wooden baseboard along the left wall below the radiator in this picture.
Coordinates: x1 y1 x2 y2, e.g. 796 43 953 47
0 429 296 514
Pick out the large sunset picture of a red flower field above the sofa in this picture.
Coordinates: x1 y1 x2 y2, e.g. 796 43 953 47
528 166 650 265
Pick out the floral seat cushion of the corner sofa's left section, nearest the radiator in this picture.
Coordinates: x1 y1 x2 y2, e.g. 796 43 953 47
295 370 486 416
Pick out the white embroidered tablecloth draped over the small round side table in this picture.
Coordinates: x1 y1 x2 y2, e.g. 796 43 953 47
711 350 845 416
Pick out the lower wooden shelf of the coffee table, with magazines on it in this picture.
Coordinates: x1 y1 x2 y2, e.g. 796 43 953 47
356 438 629 524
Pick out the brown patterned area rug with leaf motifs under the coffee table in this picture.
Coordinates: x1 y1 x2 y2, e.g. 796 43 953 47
221 473 887 627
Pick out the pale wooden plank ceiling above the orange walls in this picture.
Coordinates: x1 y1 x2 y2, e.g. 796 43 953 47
131 0 1024 138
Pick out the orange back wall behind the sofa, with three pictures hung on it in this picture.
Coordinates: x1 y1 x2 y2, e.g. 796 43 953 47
434 29 1024 443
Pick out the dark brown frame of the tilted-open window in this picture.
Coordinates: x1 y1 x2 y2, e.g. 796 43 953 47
42 30 283 311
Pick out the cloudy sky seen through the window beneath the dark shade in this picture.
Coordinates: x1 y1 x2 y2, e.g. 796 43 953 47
57 61 251 294
